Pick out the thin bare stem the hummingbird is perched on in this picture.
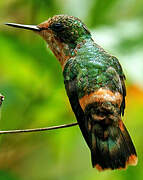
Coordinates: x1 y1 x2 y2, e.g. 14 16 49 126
0 123 78 134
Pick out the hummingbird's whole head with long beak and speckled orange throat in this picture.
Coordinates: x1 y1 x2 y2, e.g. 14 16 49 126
6 15 91 67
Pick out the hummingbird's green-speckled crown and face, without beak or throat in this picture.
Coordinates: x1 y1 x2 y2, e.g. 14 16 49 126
37 15 90 46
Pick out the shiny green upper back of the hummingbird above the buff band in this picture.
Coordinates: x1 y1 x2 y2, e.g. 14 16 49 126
64 38 125 98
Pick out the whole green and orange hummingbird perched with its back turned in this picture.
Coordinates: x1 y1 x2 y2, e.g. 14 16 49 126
6 15 137 171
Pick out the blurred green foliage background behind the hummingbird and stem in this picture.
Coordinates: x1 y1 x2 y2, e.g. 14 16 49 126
0 0 143 180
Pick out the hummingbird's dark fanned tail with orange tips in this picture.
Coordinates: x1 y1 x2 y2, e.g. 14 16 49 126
91 120 137 171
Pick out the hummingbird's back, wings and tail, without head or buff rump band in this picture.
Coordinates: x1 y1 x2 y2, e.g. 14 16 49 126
63 38 136 170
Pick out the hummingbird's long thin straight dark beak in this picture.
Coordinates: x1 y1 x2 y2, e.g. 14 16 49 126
5 23 41 31
